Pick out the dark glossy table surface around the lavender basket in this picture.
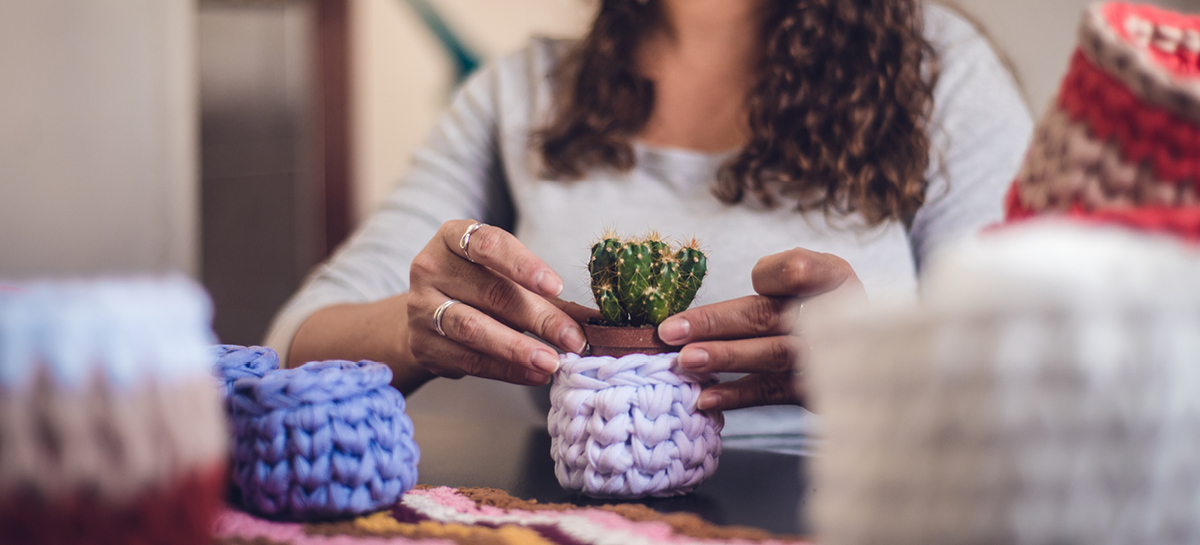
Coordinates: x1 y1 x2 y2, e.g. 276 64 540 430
413 414 811 534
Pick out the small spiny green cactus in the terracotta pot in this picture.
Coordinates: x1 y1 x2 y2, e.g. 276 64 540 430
588 233 708 327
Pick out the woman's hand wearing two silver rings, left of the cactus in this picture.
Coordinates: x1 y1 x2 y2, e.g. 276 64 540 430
407 220 598 385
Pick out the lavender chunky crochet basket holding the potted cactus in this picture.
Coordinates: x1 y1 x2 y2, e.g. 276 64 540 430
547 353 725 498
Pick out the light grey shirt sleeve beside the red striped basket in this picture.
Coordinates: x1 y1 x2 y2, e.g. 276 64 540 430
910 4 1033 270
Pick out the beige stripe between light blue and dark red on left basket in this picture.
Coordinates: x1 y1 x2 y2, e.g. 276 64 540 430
0 372 227 499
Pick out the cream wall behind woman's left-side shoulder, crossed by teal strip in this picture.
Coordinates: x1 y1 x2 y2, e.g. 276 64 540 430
352 0 593 223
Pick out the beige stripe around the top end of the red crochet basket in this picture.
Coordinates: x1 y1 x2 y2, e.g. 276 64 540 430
1079 2 1200 122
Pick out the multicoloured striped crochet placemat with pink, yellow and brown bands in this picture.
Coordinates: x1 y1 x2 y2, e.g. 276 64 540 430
216 485 809 545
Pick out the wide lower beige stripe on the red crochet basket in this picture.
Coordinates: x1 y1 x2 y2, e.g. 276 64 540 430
1016 104 1200 211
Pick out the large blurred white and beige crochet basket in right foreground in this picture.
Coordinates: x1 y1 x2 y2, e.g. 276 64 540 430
809 222 1200 545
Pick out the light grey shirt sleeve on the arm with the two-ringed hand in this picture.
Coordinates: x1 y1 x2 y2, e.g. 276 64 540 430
264 59 512 360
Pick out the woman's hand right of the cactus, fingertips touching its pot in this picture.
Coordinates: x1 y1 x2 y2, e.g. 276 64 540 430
659 248 865 411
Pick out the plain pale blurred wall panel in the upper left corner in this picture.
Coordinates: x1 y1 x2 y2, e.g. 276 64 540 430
0 0 198 279
